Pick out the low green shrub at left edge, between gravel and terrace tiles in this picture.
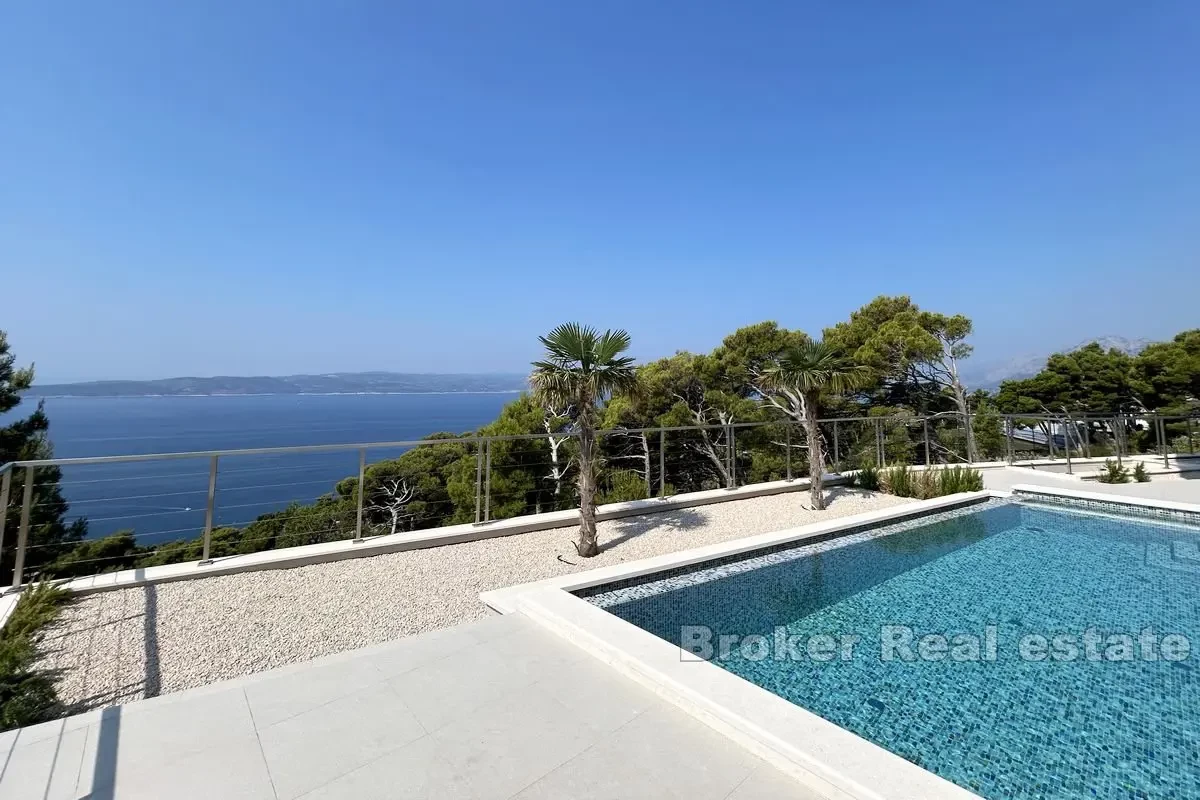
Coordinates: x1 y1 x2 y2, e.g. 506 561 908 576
0 582 68 730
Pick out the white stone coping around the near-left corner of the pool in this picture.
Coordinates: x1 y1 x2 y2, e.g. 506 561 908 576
480 489 998 800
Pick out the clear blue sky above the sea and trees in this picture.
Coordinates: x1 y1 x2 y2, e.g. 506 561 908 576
0 0 1200 380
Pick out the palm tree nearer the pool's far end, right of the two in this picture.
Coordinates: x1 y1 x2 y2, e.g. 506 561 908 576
760 341 870 510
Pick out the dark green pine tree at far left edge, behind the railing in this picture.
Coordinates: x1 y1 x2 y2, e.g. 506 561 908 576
0 331 88 585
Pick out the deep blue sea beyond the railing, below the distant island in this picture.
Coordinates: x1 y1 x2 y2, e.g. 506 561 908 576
8 392 517 545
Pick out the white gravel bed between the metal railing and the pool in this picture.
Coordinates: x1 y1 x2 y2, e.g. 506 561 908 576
41 488 911 710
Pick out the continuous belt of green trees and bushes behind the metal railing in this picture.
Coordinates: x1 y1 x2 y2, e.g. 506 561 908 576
35 321 1200 579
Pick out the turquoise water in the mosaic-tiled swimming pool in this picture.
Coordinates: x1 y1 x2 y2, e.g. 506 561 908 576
587 501 1200 800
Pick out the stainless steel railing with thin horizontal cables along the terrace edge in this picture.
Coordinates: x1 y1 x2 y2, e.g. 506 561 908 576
0 413 1195 588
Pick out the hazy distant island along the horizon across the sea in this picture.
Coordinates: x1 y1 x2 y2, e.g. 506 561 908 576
24 372 527 397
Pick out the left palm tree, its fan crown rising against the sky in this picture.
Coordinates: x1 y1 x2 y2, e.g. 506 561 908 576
529 323 637 558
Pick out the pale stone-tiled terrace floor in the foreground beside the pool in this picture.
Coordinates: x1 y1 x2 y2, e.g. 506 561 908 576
0 614 815 800
